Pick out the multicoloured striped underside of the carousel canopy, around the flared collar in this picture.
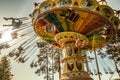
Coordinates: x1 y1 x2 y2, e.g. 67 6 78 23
35 9 114 47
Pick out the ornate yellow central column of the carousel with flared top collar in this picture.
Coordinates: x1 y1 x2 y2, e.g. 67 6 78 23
55 32 93 80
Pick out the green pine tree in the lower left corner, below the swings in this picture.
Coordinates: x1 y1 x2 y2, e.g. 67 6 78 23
0 56 13 80
